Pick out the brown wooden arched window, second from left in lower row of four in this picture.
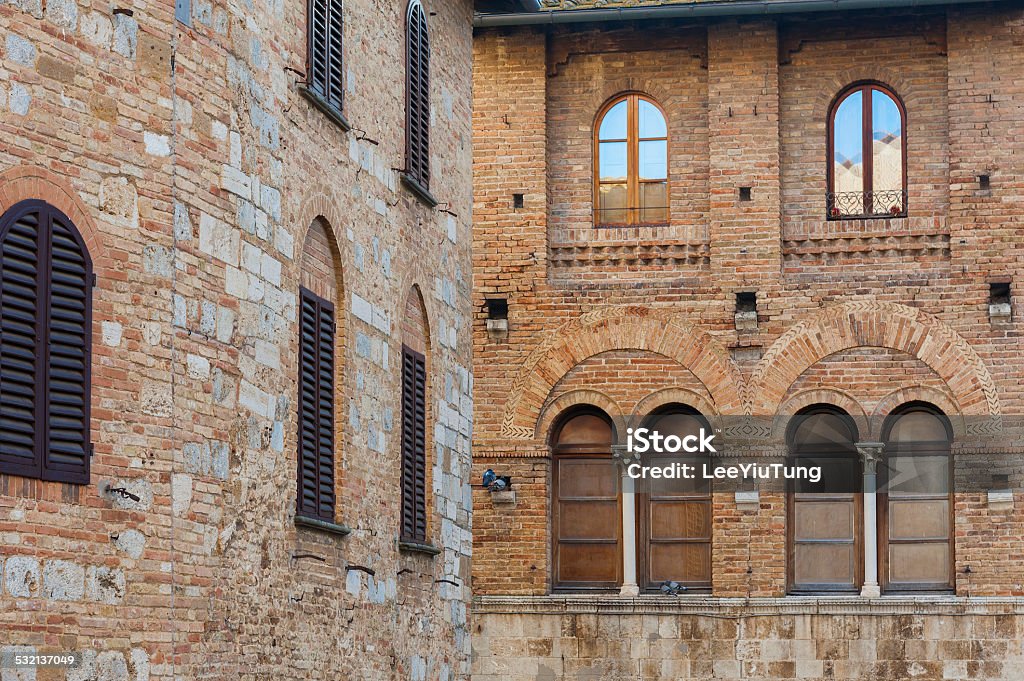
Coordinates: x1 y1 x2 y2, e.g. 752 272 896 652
637 405 713 591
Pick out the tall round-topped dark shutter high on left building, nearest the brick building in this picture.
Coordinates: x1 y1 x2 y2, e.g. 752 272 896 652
406 0 430 189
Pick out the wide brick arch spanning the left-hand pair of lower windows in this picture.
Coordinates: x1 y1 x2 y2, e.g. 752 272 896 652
502 306 743 439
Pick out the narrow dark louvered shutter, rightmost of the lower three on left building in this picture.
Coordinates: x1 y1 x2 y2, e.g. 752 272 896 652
401 345 427 542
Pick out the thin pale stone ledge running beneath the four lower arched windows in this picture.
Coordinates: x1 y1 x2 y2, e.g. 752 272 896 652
473 595 1024 618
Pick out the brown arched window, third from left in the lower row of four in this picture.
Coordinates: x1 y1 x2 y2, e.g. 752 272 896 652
786 405 864 593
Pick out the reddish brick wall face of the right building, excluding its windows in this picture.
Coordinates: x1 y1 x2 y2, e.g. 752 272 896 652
473 2 1024 679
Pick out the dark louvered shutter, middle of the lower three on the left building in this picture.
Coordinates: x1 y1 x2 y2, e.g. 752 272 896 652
298 289 335 522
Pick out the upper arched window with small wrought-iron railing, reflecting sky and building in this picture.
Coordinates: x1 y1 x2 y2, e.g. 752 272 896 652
826 83 907 219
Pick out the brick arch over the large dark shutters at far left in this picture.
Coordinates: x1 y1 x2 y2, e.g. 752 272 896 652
0 166 113 268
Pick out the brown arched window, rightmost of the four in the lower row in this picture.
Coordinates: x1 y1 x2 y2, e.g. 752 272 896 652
879 402 953 591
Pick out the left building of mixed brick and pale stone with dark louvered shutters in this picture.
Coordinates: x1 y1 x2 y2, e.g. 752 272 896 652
0 0 472 681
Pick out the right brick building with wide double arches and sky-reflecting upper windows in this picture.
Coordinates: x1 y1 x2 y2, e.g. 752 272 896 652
472 0 1024 681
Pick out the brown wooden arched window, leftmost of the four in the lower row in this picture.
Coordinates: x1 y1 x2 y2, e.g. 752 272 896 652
551 408 623 589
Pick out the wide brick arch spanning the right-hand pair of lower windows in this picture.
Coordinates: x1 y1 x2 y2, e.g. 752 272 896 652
746 302 1000 415
